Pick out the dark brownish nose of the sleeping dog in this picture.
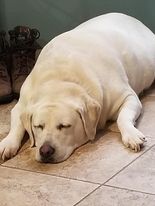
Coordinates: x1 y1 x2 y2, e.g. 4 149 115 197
39 144 55 160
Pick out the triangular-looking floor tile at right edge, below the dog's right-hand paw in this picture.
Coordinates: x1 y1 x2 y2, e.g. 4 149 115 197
107 146 155 194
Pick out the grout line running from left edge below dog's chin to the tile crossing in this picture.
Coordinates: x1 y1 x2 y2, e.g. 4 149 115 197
0 165 101 186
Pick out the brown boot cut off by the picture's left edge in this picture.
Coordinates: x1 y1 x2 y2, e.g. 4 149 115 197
0 31 13 104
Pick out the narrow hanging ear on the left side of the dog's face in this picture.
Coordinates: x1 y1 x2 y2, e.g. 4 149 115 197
20 111 35 147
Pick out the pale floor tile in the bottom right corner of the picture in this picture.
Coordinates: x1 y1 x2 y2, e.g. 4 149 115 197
77 186 155 206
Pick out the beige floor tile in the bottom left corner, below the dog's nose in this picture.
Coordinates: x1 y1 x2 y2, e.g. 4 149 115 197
0 166 98 206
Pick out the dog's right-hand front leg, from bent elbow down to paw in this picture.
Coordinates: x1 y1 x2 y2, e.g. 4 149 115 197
117 94 145 152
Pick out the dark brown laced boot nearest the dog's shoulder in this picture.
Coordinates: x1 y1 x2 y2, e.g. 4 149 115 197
9 26 41 99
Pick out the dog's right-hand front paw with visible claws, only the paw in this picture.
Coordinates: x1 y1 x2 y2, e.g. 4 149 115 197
122 127 146 152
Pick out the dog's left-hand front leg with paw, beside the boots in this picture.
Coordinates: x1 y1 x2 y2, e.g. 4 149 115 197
0 102 25 160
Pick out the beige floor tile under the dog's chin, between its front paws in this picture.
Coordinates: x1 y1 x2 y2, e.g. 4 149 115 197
4 130 152 183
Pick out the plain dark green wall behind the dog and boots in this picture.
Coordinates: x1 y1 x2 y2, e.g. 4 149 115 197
0 0 155 45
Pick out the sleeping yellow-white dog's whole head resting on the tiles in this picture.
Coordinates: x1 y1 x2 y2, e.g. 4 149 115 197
21 97 100 163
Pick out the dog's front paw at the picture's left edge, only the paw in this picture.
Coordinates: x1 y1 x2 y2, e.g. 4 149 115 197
0 137 20 161
